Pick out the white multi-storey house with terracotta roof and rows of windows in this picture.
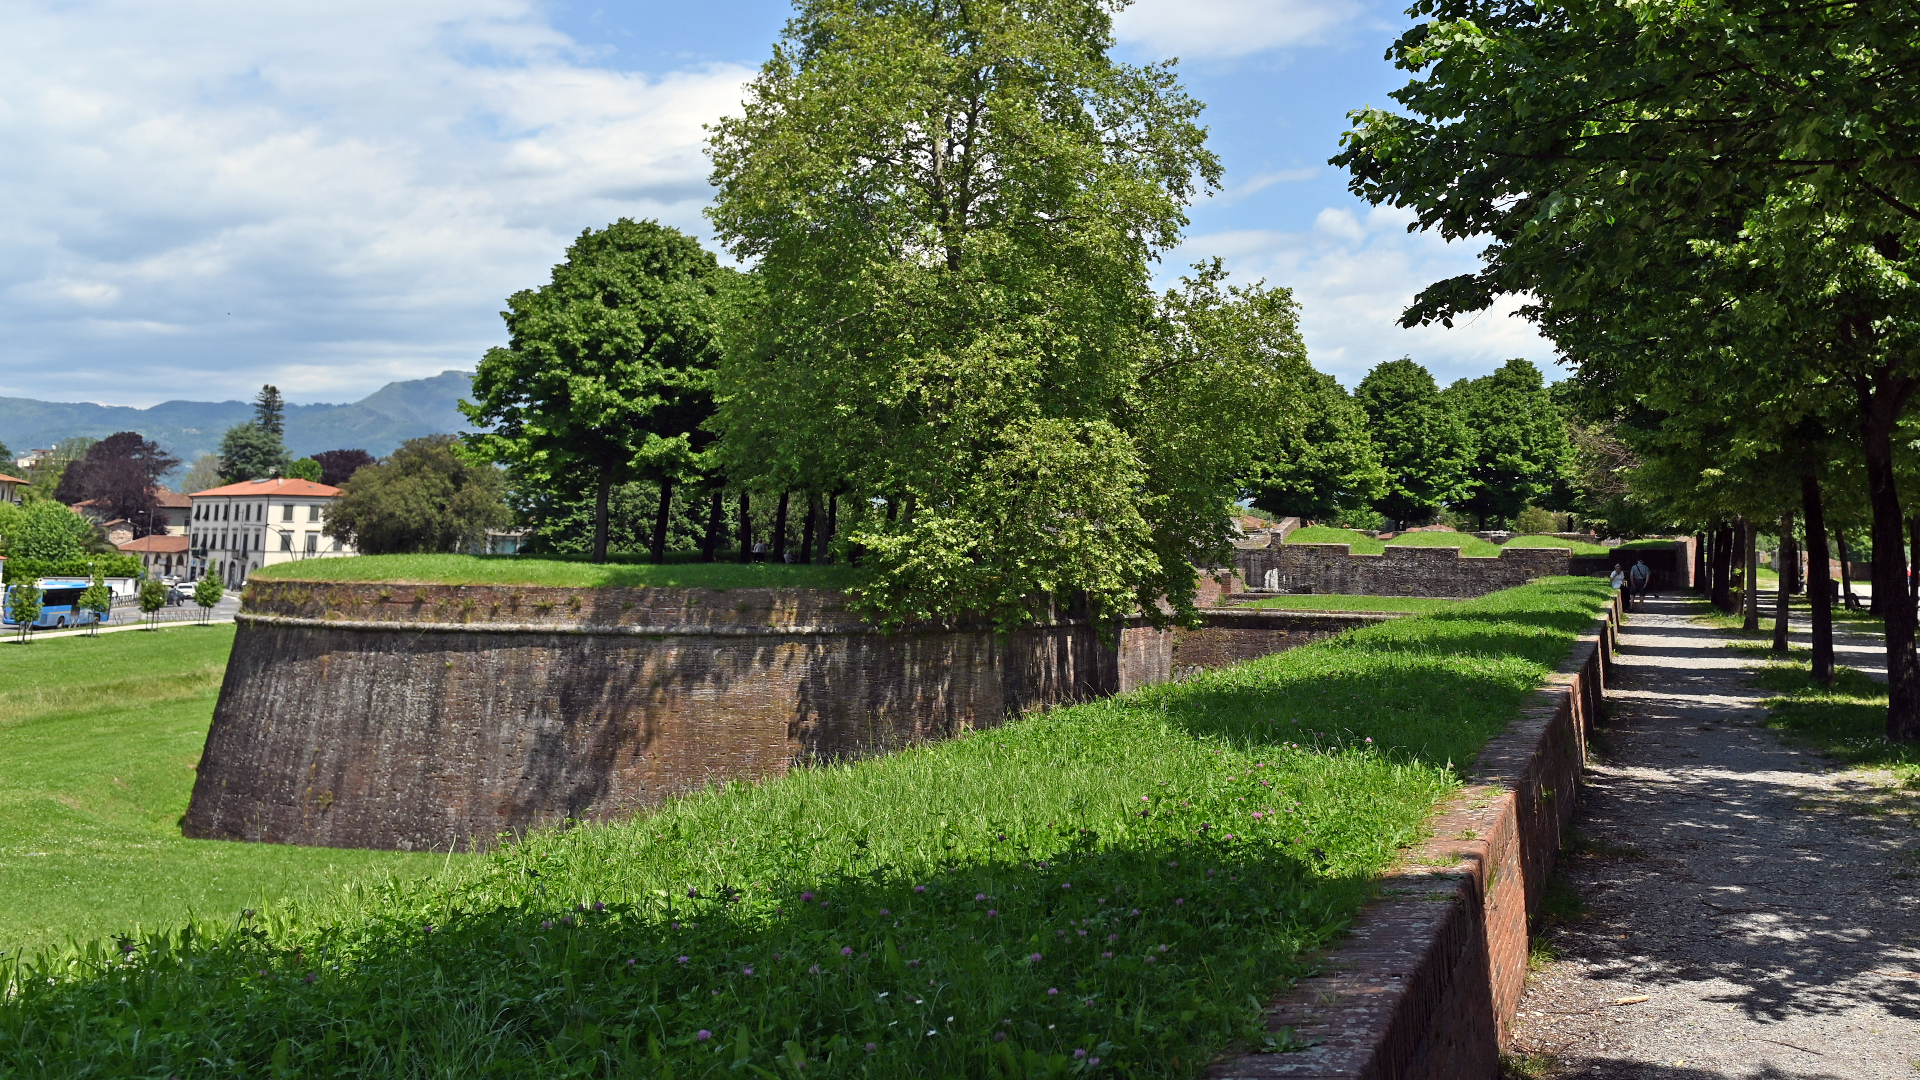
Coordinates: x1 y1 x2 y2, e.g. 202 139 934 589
186 479 355 588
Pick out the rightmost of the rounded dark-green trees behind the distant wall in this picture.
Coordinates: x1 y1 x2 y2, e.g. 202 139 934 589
1446 359 1572 528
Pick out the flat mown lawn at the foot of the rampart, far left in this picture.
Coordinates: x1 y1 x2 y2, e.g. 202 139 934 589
0 625 456 953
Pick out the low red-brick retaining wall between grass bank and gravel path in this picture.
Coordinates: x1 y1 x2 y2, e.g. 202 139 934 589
1208 591 1619 1080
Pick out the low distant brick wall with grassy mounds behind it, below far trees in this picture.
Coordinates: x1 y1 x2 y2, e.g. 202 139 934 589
1236 544 1578 598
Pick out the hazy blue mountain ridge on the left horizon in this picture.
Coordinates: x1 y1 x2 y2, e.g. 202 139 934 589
0 371 472 469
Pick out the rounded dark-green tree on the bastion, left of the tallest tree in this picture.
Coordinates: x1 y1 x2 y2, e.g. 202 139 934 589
461 217 730 561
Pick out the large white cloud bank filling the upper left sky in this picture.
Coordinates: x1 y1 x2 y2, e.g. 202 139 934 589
0 0 749 404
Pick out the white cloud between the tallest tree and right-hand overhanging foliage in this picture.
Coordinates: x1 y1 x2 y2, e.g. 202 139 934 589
1165 208 1557 388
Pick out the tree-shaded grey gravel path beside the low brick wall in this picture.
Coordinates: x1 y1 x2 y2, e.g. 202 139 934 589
1509 598 1920 1080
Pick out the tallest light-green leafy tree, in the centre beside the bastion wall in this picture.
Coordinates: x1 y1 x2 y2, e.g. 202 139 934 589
708 0 1228 625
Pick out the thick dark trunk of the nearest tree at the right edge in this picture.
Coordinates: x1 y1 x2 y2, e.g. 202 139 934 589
1860 392 1920 742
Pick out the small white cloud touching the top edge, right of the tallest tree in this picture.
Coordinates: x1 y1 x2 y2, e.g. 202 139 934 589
1114 0 1365 60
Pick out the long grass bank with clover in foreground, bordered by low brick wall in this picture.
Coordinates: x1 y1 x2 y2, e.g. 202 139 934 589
0 578 1607 1078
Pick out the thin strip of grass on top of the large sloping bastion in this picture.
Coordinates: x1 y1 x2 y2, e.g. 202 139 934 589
253 555 860 588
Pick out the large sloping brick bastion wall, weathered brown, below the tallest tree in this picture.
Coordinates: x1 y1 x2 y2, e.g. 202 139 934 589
184 580 1369 849
